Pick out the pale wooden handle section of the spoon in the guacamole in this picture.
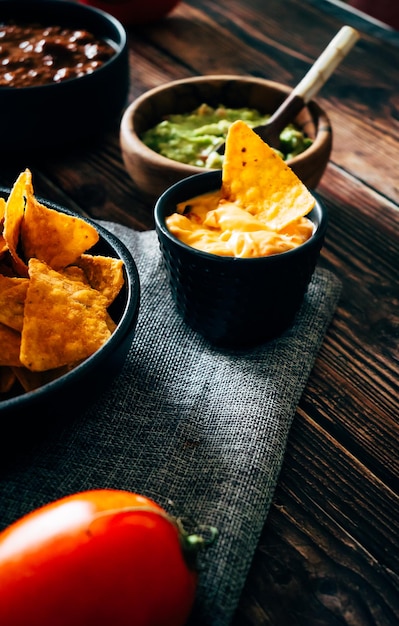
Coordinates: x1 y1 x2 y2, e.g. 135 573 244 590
293 26 360 104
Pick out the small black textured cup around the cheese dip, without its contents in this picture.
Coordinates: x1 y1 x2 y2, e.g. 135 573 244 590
154 171 327 349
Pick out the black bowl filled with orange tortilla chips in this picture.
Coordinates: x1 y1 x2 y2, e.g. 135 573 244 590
0 170 140 446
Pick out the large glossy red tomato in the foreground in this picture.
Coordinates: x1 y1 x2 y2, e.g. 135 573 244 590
0 490 197 626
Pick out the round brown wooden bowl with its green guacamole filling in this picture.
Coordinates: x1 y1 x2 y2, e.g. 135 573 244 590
120 75 332 199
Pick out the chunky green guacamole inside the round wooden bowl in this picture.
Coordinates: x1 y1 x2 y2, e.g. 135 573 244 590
142 104 312 169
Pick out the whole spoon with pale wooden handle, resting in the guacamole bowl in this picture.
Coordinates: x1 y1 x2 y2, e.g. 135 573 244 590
216 26 360 154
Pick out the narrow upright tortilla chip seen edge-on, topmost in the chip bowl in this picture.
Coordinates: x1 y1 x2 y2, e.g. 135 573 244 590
3 169 32 276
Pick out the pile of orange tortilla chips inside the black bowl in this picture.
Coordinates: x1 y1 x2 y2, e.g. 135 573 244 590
0 169 124 402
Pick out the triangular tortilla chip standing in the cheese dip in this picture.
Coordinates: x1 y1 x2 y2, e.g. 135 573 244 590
222 120 315 231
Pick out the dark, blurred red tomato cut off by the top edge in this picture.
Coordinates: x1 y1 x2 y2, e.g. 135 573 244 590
80 0 179 26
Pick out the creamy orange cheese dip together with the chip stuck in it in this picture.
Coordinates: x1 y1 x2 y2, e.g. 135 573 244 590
166 121 315 257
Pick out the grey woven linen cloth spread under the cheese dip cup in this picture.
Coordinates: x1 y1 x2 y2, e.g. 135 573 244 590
0 222 340 626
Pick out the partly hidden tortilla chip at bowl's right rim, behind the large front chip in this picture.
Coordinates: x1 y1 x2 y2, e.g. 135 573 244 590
76 254 124 306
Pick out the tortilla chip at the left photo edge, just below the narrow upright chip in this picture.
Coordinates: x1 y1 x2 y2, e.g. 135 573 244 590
0 274 29 332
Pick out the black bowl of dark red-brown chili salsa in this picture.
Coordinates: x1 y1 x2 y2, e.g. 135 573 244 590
0 0 129 158
